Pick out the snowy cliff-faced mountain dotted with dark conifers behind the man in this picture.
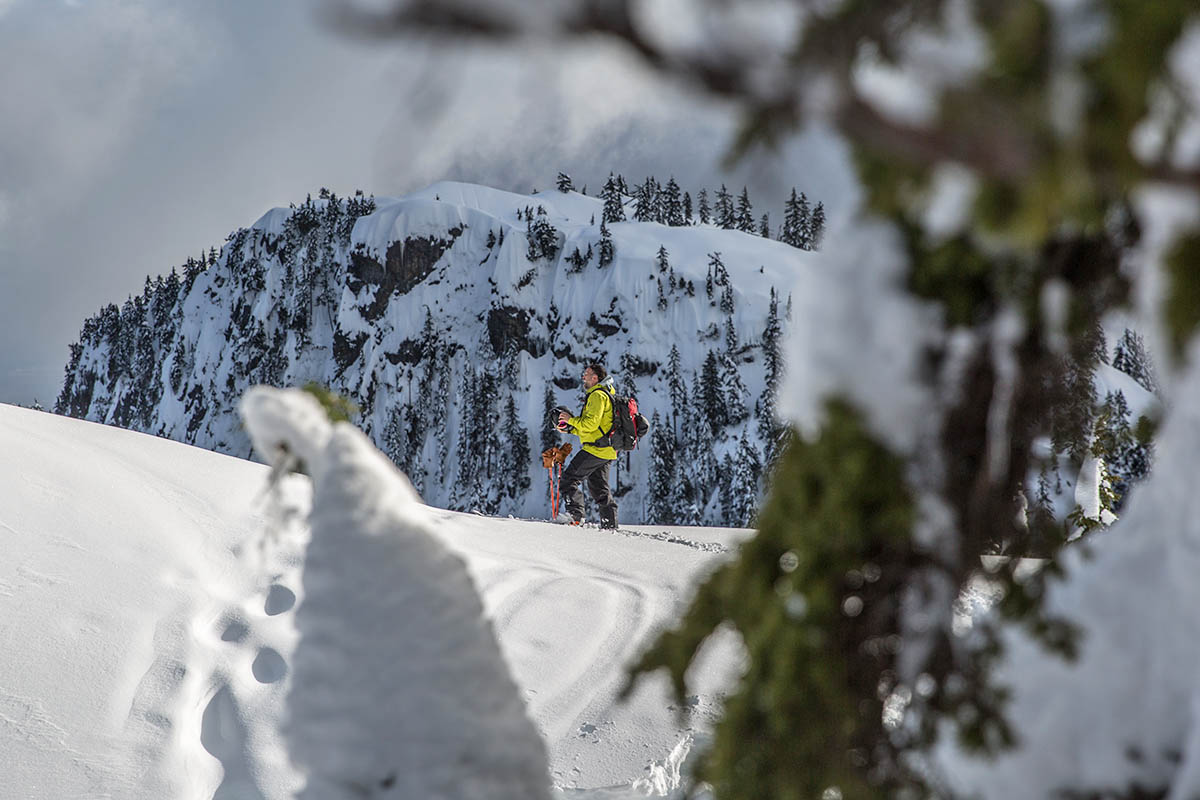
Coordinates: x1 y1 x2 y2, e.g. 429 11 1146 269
55 179 825 525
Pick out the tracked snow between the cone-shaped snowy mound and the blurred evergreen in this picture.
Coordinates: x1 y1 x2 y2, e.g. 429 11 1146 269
436 512 749 799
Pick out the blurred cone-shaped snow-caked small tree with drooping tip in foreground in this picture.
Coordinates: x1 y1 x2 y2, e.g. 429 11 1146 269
241 386 550 800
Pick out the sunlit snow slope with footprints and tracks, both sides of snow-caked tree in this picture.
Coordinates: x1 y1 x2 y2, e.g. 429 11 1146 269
0 405 746 800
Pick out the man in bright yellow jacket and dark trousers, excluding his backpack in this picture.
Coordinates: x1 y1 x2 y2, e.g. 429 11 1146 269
558 363 617 528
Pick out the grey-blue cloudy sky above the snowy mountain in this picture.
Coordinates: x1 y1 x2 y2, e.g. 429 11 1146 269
0 0 856 407
